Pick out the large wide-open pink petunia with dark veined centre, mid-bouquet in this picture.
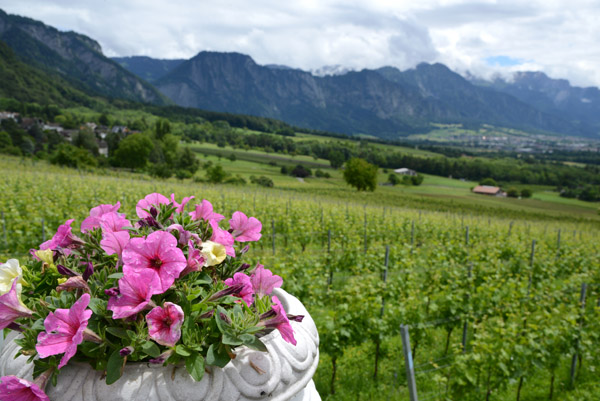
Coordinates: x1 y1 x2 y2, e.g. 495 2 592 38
123 231 187 294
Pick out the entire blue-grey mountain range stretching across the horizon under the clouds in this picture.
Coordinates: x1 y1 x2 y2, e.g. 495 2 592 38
0 10 600 139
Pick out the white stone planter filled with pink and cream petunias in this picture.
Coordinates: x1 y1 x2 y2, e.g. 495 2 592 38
0 193 319 401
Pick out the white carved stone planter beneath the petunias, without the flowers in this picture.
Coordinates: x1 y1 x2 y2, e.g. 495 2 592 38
0 289 321 401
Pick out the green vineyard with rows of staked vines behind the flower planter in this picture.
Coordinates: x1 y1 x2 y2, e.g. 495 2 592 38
0 158 600 401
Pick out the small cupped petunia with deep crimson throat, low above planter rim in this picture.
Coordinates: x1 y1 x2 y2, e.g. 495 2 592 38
146 302 183 347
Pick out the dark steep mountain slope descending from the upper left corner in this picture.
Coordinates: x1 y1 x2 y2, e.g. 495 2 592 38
0 10 168 104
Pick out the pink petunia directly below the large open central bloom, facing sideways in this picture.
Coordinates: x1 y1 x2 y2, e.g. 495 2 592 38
106 266 160 319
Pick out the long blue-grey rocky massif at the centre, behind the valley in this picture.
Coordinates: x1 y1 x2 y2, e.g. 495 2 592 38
155 52 578 138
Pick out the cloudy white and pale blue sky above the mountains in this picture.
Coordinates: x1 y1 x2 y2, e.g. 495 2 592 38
0 0 600 86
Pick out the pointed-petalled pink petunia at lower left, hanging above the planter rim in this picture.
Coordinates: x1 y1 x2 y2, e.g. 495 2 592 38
35 293 101 369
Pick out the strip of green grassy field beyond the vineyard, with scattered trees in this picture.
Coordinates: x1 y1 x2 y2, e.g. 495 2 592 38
189 143 600 223
